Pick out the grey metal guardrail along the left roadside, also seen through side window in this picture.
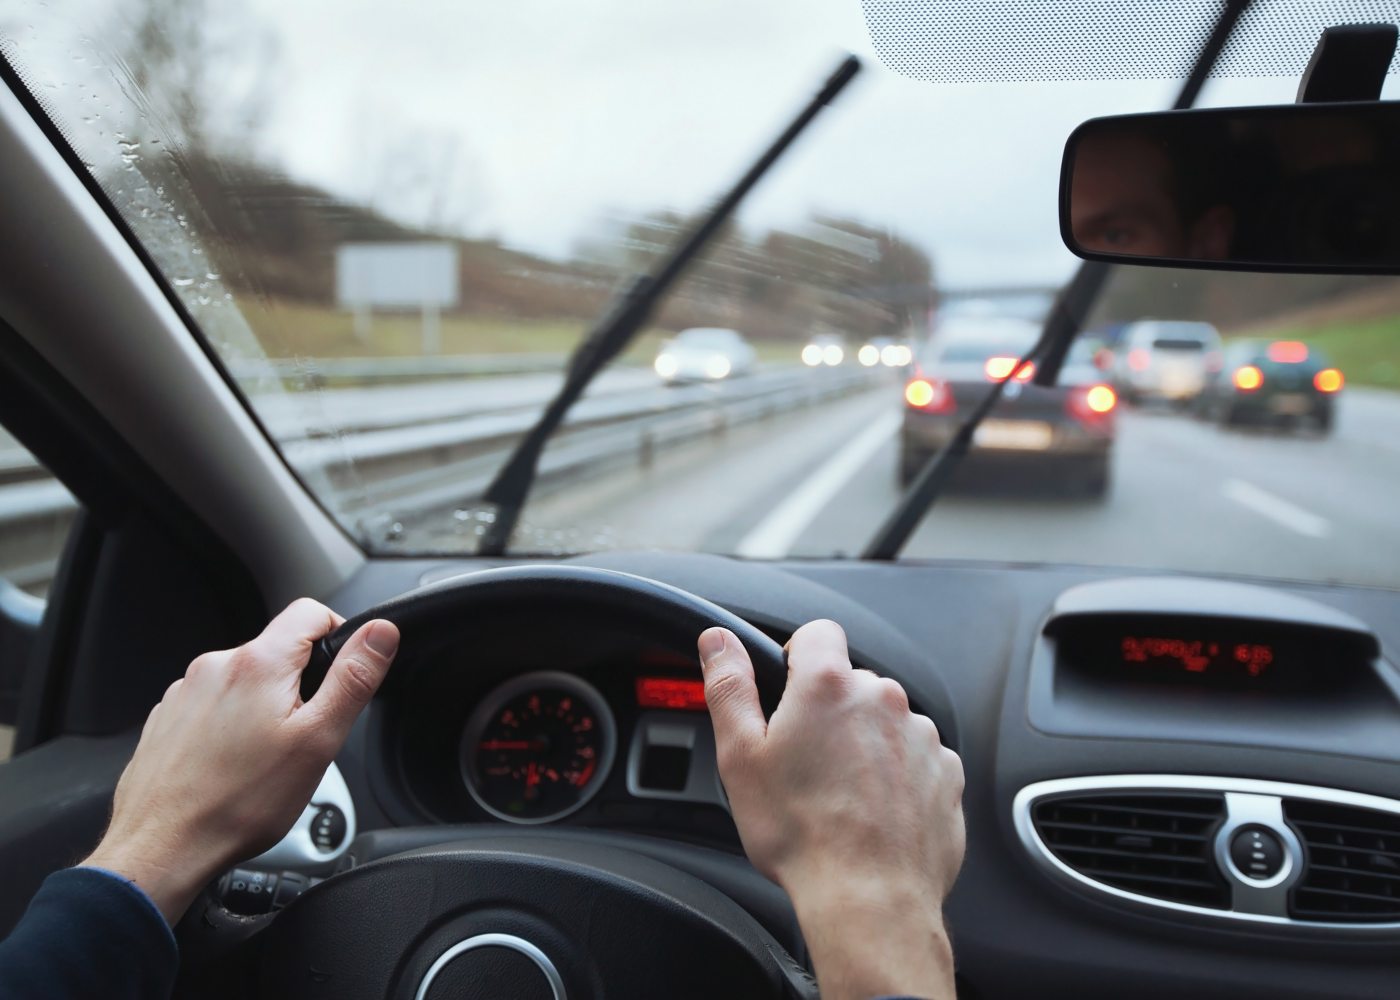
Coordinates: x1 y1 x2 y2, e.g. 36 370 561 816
0 356 881 590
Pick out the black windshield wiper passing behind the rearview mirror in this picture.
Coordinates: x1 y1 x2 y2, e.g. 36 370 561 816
861 0 1250 560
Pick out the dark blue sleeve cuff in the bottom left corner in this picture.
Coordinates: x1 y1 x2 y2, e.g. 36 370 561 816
0 868 179 1000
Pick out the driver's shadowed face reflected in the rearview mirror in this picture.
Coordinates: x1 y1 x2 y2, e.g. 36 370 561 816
1070 132 1233 259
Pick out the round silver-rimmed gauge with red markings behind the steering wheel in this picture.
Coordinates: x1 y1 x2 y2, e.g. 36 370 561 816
461 672 617 824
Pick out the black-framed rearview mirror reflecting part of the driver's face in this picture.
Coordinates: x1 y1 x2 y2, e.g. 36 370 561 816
1060 102 1400 275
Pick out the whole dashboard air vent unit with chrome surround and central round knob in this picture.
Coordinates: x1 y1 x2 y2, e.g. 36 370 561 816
1012 775 1400 934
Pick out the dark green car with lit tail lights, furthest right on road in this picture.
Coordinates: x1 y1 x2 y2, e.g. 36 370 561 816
1198 340 1345 434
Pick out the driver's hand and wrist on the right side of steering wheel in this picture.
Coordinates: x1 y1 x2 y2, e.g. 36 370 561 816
700 620 965 1000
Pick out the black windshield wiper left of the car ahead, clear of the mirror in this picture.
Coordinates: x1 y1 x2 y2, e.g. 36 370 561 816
477 56 861 556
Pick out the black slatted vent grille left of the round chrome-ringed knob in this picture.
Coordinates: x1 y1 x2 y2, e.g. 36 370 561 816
1032 791 1226 909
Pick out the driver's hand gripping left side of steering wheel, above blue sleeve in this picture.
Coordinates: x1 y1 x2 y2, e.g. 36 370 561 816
84 598 399 924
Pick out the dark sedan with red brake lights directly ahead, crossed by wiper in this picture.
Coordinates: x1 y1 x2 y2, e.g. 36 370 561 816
899 319 1117 497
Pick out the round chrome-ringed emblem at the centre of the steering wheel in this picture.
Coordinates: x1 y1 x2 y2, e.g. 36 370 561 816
414 934 567 1000
